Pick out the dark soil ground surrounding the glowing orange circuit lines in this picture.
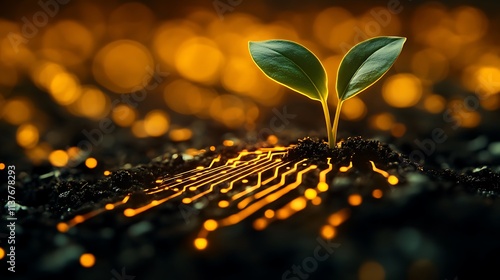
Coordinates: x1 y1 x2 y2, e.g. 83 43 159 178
1 131 500 279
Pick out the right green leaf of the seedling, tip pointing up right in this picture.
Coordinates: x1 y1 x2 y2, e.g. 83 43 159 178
337 37 406 101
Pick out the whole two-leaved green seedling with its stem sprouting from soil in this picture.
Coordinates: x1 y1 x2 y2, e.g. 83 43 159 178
248 36 406 148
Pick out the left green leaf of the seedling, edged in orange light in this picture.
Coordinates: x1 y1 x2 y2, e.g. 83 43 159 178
248 40 328 102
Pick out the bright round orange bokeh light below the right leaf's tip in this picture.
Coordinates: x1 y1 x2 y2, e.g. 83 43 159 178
382 74 422 108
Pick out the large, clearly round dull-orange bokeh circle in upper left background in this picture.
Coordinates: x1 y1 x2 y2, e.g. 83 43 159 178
92 40 155 93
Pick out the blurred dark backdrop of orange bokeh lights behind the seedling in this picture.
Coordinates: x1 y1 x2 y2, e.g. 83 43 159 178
0 0 500 169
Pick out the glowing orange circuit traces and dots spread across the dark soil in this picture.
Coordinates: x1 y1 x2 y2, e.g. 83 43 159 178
57 144 399 252
